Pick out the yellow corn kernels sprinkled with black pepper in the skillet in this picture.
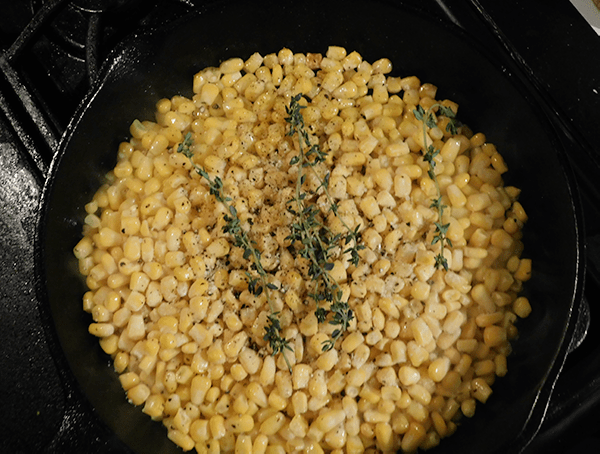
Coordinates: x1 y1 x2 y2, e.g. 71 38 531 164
74 46 531 453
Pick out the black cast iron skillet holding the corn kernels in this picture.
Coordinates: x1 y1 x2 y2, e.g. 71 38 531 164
39 0 583 453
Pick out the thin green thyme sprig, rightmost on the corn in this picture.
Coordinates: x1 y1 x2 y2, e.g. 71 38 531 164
413 103 460 271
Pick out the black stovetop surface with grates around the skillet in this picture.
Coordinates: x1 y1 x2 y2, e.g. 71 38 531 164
0 0 600 454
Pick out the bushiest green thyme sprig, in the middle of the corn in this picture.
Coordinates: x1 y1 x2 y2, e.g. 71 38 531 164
286 94 364 351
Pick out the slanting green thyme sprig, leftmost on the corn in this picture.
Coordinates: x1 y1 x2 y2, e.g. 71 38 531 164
177 132 293 372
